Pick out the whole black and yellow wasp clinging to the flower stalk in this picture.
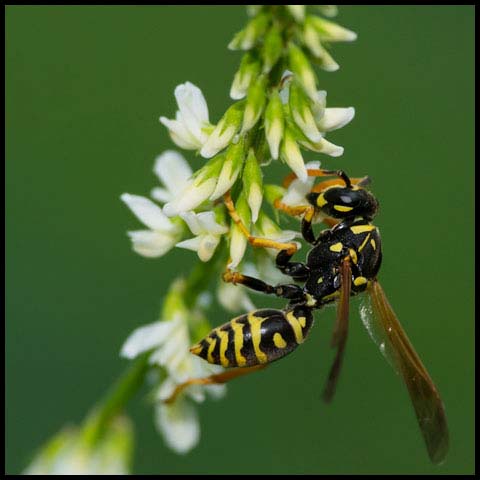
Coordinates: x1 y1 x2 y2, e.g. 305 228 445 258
167 169 449 463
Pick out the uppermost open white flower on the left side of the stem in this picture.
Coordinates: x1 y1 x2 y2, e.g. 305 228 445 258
160 82 212 150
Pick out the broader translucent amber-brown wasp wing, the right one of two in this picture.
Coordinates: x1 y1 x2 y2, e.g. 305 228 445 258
360 281 449 463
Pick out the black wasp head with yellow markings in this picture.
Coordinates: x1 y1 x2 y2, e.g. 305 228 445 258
307 185 378 220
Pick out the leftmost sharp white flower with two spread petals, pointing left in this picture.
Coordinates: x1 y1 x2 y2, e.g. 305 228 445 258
120 193 181 257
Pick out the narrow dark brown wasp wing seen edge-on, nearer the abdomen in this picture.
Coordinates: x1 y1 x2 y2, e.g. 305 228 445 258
323 257 352 402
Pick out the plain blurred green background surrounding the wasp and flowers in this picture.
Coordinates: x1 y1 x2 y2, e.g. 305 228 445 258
6 6 474 474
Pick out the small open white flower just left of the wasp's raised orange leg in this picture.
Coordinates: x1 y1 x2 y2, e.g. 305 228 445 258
176 212 228 262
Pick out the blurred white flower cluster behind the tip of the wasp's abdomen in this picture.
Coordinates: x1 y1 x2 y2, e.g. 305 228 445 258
121 309 226 453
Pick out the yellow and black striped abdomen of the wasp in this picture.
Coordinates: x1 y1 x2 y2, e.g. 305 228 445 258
190 306 313 367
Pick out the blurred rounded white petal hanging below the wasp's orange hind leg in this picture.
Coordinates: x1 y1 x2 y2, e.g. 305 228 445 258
155 397 200 453
